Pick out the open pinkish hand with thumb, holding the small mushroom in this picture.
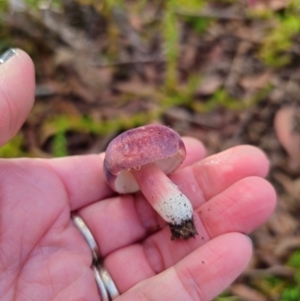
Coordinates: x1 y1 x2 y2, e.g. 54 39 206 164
0 50 276 301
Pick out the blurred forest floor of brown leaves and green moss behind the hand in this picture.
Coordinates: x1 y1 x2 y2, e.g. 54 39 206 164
0 0 300 301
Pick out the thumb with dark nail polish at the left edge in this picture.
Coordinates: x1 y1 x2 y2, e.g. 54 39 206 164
0 49 35 146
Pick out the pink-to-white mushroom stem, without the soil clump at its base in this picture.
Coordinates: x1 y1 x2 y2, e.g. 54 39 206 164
131 163 193 226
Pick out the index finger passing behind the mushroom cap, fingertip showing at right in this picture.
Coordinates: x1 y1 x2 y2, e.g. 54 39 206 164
44 138 205 210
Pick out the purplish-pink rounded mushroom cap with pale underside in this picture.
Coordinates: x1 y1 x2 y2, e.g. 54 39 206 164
103 124 186 193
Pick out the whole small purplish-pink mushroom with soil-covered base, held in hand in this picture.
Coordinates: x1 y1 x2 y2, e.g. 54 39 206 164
103 124 198 240
